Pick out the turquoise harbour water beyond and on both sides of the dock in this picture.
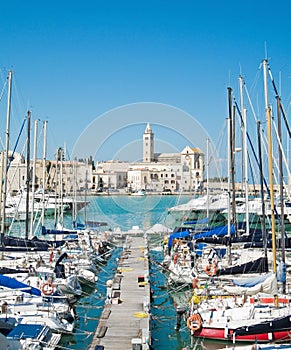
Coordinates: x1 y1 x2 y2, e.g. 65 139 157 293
63 196 198 350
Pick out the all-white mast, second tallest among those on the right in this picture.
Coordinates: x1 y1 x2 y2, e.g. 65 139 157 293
239 76 250 234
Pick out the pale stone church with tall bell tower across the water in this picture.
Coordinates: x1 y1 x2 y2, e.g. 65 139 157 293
127 123 204 192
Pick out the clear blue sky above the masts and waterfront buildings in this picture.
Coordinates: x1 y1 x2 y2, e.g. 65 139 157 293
0 0 291 170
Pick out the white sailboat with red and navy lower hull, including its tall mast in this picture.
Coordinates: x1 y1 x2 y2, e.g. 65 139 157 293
187 60 291 343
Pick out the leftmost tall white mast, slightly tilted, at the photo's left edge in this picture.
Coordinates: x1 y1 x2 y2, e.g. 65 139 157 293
1 71 12 253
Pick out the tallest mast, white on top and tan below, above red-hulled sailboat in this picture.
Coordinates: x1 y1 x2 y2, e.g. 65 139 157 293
263 59 278 305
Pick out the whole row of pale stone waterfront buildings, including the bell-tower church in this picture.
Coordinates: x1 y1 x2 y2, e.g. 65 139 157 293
0 123 204 194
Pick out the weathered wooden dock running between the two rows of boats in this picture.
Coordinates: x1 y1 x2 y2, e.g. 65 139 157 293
90 235 151 350
